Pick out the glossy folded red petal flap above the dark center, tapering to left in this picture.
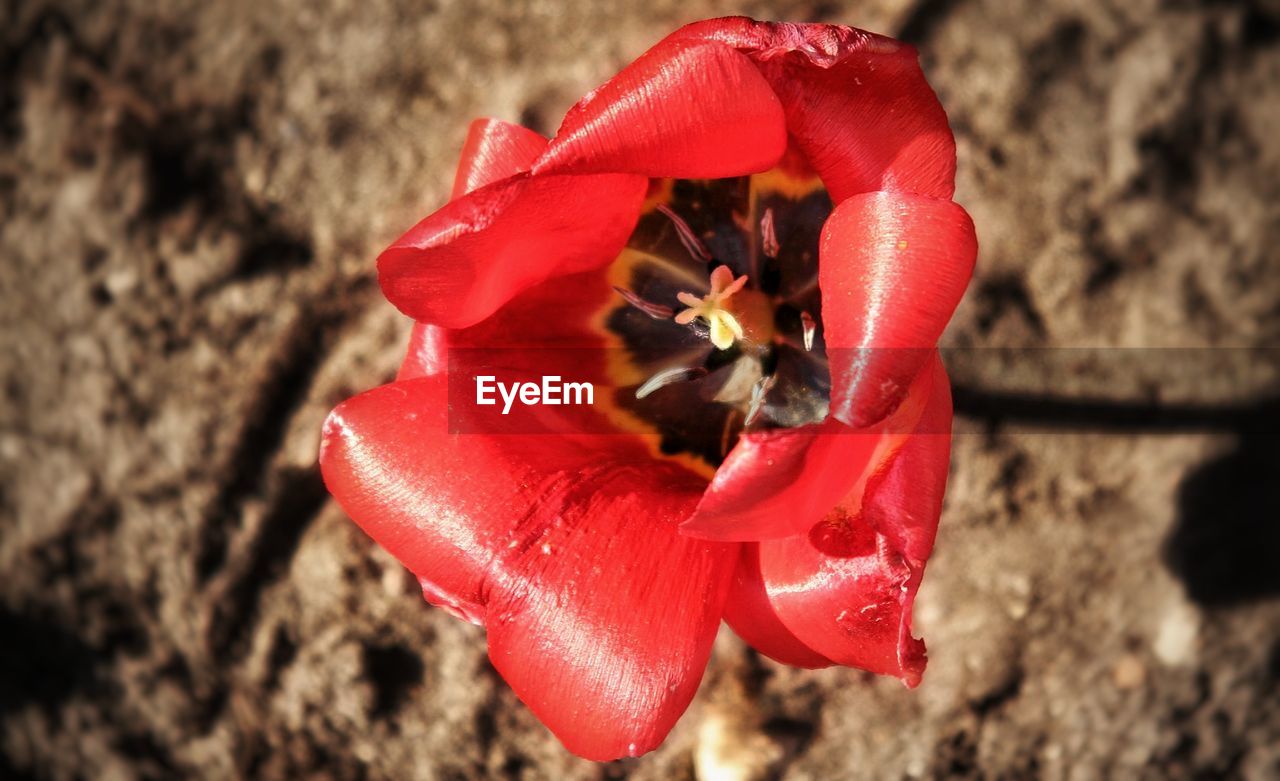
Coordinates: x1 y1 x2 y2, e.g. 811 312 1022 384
534 41 787 178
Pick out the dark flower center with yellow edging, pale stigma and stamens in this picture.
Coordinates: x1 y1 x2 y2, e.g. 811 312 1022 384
604 169 831 466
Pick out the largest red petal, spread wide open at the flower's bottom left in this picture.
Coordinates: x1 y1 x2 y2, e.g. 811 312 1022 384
320 375 737 761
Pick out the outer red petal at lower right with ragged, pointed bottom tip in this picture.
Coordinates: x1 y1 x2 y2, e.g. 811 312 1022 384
759 361 951 686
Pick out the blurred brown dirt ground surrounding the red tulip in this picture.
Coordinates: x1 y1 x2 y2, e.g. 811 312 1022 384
0 0 1280 781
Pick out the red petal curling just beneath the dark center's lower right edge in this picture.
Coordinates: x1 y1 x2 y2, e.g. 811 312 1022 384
681 351 932 542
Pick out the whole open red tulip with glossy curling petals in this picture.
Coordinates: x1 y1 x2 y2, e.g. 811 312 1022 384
321 18 977 759
